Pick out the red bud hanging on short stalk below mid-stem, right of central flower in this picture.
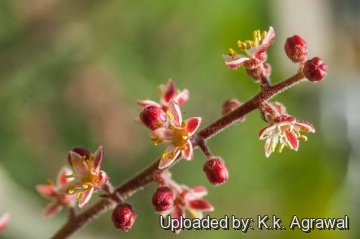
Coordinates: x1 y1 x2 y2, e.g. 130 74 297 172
203 157 229 186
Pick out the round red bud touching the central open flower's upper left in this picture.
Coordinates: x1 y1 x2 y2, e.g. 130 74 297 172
140 105 168 130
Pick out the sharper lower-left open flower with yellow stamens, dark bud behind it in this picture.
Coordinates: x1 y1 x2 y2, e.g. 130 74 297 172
59 146 109 208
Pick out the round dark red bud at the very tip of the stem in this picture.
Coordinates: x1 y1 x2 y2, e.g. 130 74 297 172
303 57 328 82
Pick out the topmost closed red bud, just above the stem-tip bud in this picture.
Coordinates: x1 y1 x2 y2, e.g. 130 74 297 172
284 35 308 62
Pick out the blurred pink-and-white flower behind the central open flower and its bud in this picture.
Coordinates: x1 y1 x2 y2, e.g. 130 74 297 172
137 79 190 111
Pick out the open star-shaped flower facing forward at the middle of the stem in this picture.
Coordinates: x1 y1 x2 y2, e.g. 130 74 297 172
149 100 201 169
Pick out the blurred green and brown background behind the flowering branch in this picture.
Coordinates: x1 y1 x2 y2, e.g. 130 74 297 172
0 0 360 239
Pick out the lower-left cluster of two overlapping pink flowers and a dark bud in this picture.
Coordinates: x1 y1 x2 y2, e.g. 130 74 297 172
36 146 109 218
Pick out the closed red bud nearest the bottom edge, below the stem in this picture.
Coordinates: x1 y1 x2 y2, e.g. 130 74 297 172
111 203 136 232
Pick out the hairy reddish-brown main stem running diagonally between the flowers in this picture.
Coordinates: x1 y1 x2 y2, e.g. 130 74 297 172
52 72 304 239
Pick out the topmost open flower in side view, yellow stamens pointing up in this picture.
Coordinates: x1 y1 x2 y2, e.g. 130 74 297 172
223 27 275 69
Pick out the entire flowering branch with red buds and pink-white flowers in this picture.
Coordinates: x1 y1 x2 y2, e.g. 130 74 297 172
38 27 327 239
